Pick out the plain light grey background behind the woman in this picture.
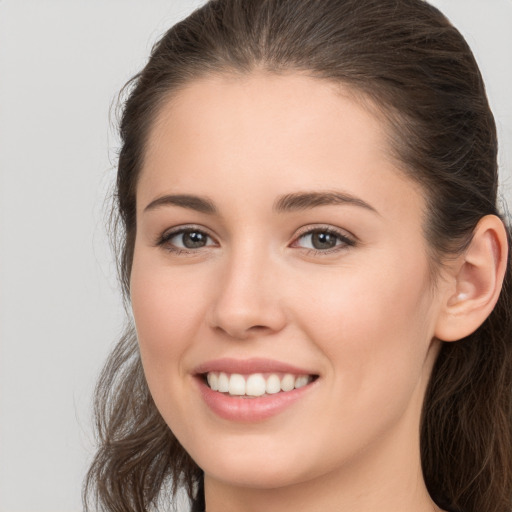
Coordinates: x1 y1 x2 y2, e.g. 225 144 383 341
0 0 512 512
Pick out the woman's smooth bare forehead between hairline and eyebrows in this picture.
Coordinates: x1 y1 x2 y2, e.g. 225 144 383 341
138 72 421 222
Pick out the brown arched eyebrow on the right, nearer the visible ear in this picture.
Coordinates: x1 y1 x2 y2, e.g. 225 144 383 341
274 191 379 214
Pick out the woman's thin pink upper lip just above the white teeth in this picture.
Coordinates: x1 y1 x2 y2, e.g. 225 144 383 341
193 358 317 375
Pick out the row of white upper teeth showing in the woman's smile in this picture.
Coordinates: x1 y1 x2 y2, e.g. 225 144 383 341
206 372 312 396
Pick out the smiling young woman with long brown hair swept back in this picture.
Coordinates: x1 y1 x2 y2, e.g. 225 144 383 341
85 0 512 512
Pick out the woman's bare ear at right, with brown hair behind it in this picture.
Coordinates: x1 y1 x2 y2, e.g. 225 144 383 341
435 215 508 341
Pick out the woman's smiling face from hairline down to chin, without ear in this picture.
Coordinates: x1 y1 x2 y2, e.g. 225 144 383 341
131 74 448 487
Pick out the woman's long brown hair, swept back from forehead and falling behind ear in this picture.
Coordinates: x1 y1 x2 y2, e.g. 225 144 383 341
84 0 512 512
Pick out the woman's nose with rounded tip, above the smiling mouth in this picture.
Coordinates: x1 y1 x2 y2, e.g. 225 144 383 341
211 250 286 340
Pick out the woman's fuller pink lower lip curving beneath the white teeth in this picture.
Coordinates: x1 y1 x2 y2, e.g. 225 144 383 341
196 377 316 423
